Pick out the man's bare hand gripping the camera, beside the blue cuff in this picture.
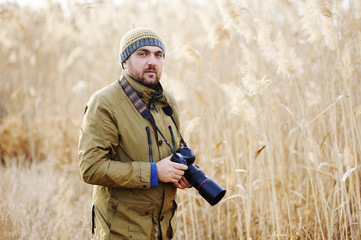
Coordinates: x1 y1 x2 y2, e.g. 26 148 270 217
157 155 188 183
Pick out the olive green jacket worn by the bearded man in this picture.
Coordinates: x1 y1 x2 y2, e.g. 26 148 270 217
78 75 180 240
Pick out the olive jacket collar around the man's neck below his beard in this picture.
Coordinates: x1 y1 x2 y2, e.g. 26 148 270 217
123 72 163 107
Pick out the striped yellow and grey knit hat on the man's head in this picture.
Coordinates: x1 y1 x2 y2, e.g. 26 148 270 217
119 27 165 64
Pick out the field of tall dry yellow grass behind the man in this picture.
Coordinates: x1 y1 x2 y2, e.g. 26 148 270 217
0 0 361 240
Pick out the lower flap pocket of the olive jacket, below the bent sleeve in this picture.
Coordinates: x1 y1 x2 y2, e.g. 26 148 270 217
109 201 154 239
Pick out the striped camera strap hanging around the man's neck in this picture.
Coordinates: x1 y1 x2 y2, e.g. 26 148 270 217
118 76 176 154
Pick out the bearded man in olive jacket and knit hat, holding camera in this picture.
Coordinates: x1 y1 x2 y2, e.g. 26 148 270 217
78 28 190 240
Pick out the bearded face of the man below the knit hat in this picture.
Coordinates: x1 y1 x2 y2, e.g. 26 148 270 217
123 46 164 88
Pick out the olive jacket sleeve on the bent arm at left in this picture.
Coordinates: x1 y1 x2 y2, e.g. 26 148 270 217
78 95 151 189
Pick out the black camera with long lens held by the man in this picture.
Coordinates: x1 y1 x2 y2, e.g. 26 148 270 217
170 147 226 206
